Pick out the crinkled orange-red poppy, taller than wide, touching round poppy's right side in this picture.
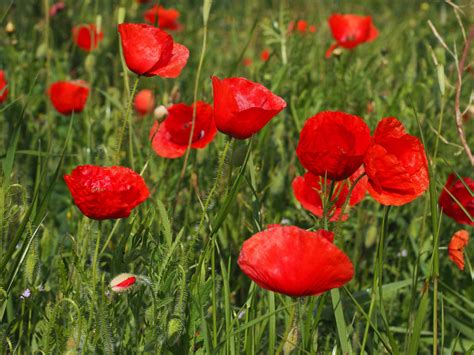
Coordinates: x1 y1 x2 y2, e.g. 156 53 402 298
364 117 430 206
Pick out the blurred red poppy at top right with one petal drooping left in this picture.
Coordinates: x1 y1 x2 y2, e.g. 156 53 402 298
326 14 379 58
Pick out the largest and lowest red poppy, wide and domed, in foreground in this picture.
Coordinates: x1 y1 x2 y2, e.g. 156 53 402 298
238 226 354 297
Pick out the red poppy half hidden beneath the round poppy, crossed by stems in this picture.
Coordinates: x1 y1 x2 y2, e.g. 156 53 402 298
292 167 367 222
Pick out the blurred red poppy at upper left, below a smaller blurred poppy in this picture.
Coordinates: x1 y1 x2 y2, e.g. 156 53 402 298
48 80 89 115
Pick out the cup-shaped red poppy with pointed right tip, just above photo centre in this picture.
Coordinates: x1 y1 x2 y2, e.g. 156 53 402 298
212 76 286 139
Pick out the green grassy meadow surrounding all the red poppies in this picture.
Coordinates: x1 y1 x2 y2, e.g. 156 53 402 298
0 0 474 354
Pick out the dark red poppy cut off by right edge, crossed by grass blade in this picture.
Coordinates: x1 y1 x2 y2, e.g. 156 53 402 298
438 174 474 226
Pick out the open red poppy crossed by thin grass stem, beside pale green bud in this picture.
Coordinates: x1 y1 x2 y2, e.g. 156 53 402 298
150 101 217 158
